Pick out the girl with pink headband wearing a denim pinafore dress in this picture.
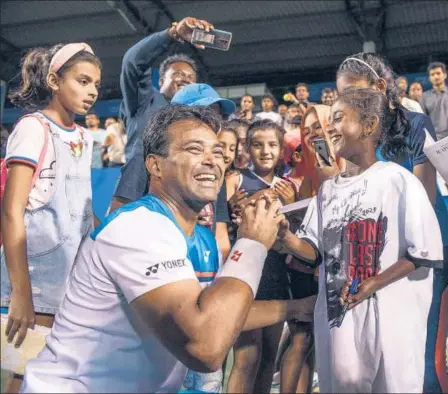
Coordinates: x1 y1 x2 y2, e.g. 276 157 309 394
1 43 101 390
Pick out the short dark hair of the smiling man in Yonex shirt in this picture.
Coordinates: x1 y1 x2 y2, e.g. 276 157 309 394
143 105 221 158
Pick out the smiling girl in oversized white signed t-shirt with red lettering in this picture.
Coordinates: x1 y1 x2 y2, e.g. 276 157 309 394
280 88 442 393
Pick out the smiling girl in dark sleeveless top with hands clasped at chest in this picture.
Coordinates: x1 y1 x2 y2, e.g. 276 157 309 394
227 120 295 393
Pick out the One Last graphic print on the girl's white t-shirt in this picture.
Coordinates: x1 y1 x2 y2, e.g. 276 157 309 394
322 183 387 328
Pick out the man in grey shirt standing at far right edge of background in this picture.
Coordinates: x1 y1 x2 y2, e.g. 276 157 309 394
420 62 448 140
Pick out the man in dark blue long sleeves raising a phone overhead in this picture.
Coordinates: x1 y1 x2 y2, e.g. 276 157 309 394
110 17 213 211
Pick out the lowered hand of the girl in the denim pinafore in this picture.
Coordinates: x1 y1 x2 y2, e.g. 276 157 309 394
5 291 36 348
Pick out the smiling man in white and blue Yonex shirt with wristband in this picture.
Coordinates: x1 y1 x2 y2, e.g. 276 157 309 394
21 105 284 393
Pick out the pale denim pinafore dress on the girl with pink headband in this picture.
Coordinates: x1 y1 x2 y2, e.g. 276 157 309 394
0 113 93 314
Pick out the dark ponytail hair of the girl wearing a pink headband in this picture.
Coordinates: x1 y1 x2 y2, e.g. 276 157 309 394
8 44 101 112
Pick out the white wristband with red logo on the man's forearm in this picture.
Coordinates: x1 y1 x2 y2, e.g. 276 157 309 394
216 238 268 297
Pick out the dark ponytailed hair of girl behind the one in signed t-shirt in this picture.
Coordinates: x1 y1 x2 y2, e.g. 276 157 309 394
337 52 411 161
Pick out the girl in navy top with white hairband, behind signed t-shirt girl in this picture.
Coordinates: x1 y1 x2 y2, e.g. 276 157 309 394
337 53 448 393
